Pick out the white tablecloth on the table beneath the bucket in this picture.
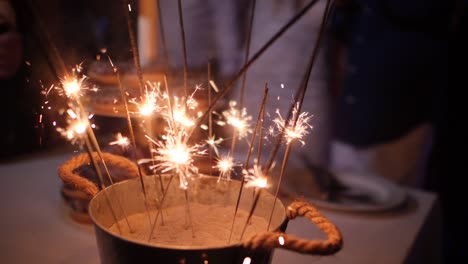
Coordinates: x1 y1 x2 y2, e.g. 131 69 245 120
0 153 441 264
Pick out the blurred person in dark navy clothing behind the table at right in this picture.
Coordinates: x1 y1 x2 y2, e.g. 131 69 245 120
332 0 452 187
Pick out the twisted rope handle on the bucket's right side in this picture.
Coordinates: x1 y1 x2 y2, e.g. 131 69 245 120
243 200 343 255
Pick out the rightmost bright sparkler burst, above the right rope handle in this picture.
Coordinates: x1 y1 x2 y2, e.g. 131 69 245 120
270 105 312 145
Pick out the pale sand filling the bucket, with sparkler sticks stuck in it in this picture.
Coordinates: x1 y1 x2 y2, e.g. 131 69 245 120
110 203 268 248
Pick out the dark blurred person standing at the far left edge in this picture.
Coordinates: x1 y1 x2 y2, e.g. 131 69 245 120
0 0 37 159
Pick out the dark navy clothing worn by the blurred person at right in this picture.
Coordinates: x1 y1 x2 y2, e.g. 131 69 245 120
330 1 450 147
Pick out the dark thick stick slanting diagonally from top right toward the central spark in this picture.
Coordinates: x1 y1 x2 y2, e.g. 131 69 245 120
189 0 318 142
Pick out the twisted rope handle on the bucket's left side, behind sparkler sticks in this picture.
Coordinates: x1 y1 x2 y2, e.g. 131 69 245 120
57 152 138 198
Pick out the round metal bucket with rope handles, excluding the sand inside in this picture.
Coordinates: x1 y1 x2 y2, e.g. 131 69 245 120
89 176 288 264
